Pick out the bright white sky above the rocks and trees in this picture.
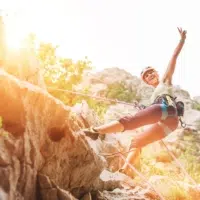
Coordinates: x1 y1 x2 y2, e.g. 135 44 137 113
0 0 200 96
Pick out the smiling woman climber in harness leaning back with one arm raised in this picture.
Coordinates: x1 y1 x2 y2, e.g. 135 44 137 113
83 28 187 175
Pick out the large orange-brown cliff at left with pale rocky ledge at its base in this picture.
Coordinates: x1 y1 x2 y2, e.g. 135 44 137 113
0 69 157 200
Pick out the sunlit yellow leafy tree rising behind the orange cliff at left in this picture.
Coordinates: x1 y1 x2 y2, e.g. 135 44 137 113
33 38 92 106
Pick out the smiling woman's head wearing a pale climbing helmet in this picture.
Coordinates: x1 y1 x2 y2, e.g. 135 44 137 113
142 68 159 87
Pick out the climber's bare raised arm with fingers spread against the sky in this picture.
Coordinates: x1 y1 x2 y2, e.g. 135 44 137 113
162 28 187 85
